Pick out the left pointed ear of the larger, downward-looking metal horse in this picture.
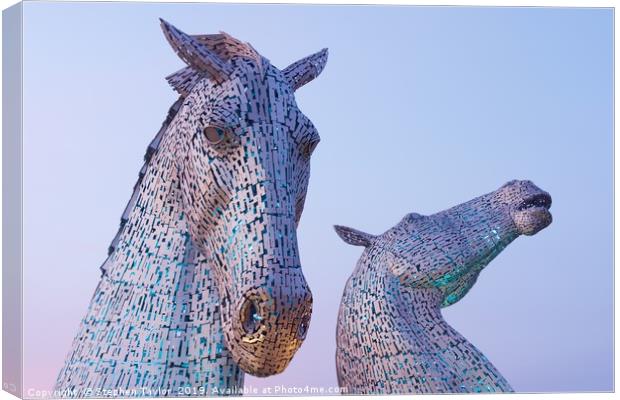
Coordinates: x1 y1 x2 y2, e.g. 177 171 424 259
160 18 232 83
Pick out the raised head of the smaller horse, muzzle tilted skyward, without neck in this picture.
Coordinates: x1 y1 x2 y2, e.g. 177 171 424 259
336 180 553 306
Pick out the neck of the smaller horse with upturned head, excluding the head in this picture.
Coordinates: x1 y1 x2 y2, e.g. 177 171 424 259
336 247 511 394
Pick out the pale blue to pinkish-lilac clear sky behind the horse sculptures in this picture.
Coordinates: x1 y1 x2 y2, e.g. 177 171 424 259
18 2 613 392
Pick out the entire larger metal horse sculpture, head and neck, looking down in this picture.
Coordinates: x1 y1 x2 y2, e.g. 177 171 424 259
55 20 327 397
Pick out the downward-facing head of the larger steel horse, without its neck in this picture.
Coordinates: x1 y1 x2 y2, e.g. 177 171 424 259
162 20 327 376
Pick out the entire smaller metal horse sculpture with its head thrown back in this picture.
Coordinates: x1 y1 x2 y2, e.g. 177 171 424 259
336 180 552 394
